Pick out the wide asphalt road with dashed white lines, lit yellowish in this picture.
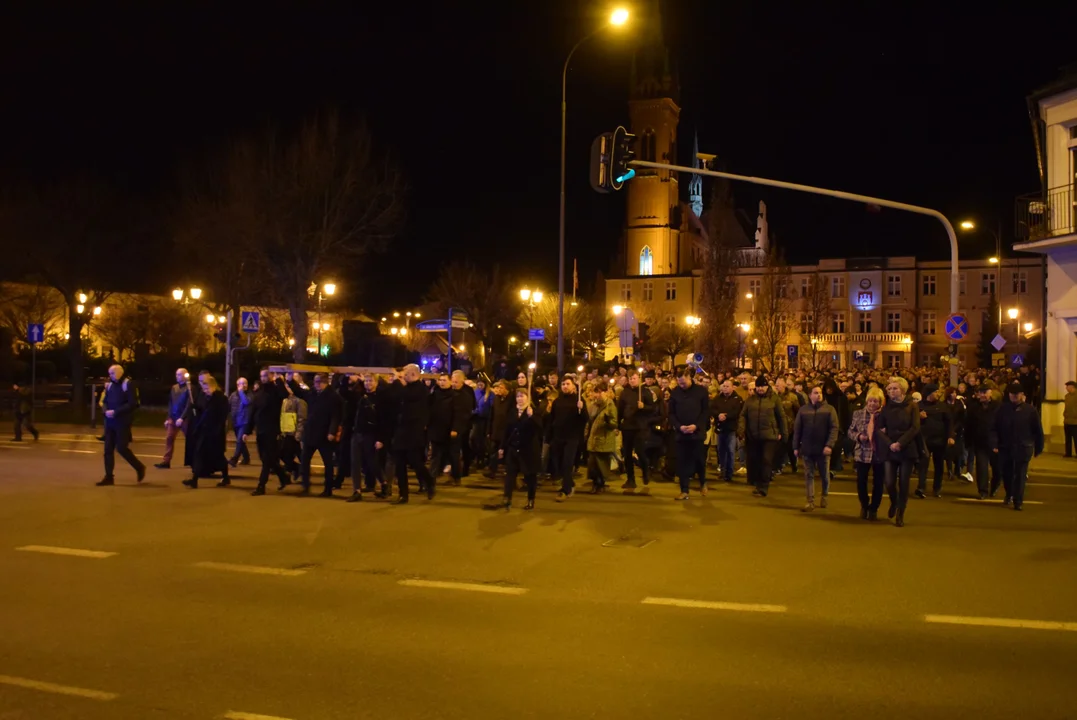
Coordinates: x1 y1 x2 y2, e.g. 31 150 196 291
0 435 1077 720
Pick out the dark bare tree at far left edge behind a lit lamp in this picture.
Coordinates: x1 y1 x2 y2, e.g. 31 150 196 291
0 178 123 406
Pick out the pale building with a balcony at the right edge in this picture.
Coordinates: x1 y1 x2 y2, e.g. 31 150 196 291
1013 67 1077 436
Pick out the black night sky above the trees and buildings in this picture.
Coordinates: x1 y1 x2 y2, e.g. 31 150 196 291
0 0 1077 311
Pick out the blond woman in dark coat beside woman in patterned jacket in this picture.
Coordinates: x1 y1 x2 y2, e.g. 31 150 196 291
875 377 920 527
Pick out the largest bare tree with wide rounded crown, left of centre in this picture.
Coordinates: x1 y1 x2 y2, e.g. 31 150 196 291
180 112 404 361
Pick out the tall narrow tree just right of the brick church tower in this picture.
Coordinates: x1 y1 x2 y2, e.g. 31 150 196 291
696 180 743 367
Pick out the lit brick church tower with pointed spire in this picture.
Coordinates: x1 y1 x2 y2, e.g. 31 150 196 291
625 0 681 277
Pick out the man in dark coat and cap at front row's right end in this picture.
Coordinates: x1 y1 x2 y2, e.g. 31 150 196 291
991 382 1044 510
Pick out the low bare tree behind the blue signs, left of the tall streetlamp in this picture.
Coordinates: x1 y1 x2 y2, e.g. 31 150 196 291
426 260 519 357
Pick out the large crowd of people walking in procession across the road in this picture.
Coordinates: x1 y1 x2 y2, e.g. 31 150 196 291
84 363 1059 526
